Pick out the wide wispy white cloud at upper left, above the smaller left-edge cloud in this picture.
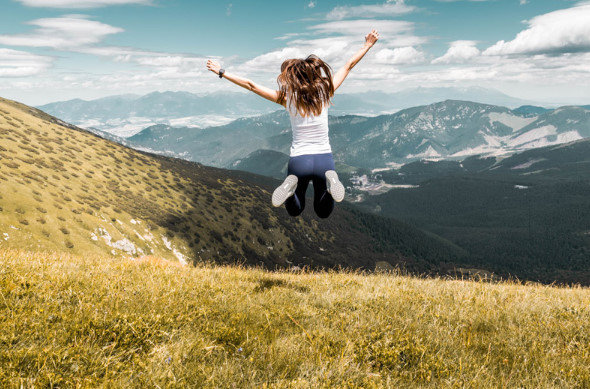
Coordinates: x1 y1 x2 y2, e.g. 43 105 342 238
0 15 123 50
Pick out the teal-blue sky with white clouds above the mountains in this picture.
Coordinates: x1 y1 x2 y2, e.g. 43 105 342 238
0 0 590 105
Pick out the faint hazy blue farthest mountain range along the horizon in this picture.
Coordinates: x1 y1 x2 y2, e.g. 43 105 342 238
39 87 530 137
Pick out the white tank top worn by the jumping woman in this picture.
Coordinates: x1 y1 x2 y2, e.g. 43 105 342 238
287 97 332 157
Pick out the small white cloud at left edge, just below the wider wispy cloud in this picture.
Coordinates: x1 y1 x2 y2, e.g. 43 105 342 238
0 48 53 77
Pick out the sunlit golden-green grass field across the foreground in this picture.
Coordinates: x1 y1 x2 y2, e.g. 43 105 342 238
0 250 590 388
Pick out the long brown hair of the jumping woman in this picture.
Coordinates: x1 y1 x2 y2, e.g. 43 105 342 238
277 55 334 116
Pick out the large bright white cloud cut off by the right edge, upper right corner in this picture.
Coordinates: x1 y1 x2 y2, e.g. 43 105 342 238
483 2 590 55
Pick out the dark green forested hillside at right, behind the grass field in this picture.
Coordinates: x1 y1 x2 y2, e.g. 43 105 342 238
360 140 590 285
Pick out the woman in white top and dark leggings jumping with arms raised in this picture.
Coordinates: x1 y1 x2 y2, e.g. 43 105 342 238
207 30 379 218
